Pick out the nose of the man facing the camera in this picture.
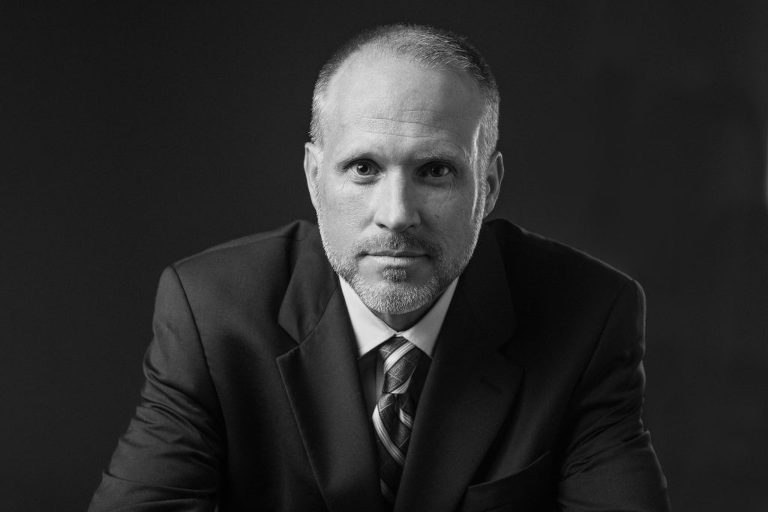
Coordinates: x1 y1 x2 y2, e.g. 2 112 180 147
373 172 421 232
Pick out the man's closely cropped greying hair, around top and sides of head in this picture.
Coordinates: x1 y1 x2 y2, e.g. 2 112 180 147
310 25 499 168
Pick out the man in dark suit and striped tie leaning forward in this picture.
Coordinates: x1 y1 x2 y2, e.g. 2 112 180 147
91 25 668 512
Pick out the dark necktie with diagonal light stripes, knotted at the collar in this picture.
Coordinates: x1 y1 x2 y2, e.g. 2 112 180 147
373 336 421 503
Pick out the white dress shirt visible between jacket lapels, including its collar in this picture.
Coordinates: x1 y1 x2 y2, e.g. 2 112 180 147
339 277 458 413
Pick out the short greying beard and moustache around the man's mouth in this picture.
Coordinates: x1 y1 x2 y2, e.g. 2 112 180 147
317 201 483 315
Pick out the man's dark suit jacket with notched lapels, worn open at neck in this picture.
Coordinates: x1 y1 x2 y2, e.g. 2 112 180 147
90 221 668 512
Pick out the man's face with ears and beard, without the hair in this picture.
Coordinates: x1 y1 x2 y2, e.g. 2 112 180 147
304 50 504 330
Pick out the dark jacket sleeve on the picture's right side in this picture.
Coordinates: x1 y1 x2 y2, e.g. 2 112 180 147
558 280 669 512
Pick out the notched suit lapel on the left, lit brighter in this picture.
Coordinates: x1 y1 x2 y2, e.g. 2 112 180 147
277 228 383 512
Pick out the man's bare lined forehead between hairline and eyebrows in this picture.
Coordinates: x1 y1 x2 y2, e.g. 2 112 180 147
324 52 483 156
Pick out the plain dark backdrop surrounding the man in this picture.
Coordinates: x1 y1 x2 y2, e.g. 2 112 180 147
0 1 768 512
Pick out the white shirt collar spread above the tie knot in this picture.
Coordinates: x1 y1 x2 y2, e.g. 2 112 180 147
339 277 458 357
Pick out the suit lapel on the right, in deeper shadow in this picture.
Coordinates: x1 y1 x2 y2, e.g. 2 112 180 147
395 230 523 512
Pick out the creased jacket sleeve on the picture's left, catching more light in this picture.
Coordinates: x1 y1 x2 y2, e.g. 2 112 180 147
89 267 225 512
